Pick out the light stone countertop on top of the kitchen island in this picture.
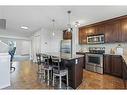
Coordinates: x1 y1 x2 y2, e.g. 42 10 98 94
45 52 83 60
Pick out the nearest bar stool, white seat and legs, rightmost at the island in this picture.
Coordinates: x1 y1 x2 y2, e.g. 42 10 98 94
52 57 68 88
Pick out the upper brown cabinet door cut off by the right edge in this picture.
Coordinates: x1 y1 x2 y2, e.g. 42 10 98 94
121 18 127 42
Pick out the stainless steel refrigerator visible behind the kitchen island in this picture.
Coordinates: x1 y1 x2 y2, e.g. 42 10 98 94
60 40 72 54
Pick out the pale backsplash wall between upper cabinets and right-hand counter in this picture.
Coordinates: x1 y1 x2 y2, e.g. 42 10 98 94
77 43 127 54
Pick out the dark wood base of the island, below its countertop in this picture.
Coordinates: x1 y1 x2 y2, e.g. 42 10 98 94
62 57 84 89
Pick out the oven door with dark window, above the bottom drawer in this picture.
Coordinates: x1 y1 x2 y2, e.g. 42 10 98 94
86 54 103 67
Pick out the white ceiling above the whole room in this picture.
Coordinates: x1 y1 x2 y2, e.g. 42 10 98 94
0 6 127 36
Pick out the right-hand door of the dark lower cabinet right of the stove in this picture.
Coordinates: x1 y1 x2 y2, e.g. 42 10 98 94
111 55 122 77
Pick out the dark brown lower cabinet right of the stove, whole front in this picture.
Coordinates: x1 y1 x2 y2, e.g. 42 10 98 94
104 55 122 77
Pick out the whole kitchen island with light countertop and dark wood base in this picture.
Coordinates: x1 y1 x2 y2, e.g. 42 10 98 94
45 52 84 89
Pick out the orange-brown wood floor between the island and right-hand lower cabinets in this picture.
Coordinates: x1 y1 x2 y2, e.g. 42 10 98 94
78 71 124 89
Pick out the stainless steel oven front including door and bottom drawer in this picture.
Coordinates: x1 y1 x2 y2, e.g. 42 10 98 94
86 53 103 74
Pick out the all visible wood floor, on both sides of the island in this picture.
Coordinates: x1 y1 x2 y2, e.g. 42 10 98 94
5 61 124 89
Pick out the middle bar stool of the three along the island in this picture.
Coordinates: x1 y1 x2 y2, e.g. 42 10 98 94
42 54 52 85
